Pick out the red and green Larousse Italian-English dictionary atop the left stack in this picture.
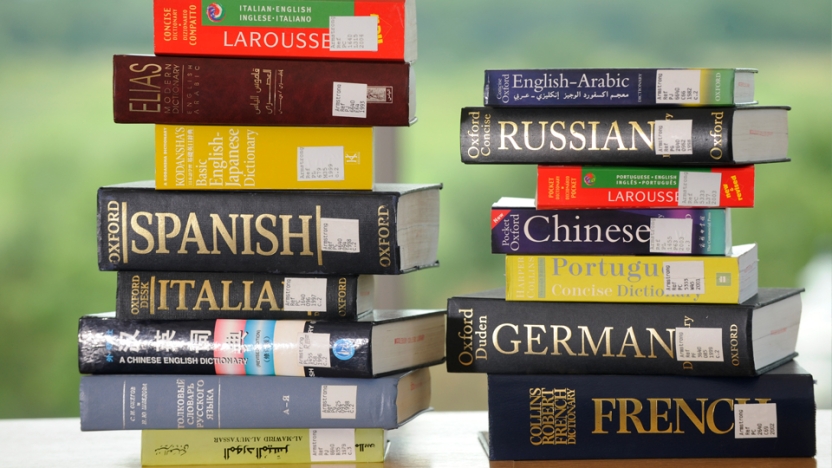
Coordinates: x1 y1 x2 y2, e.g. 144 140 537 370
153 0 416 62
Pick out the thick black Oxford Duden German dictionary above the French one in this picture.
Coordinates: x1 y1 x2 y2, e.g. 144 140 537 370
446 288 801 377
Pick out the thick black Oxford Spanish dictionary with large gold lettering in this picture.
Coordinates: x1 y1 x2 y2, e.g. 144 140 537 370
98 182 442 275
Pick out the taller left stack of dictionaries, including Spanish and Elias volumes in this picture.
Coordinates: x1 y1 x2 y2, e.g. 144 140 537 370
78 0 445 465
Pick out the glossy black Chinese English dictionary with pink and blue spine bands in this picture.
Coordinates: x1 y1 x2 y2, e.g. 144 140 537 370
78 310 445 377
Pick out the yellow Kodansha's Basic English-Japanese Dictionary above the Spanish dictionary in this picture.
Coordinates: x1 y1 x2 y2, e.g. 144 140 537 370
156 125 374 190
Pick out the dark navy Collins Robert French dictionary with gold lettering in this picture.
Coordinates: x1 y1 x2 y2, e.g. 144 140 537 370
488 374 815 460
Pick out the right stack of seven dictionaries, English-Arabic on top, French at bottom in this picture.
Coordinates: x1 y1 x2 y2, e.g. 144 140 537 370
446 69 815 460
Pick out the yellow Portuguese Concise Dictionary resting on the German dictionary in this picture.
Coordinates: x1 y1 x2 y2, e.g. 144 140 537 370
506 244 757 304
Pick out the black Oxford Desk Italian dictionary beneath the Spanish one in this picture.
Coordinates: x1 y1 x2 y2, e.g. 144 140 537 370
116 271 372 321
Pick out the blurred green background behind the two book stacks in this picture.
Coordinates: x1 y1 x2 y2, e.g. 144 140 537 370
0 0 832 418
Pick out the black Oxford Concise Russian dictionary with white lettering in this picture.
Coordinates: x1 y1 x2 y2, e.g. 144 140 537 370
459 106 789 166
